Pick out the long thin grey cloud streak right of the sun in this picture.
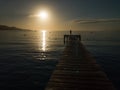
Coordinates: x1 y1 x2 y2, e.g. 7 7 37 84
73 18 120 24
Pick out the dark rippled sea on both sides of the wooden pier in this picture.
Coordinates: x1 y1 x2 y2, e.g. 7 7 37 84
0 30 120 90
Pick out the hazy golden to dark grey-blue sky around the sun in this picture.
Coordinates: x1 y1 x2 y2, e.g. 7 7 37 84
0 0 120 31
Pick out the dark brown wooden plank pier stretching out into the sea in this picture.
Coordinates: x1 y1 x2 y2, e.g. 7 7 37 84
45 35 115 90
